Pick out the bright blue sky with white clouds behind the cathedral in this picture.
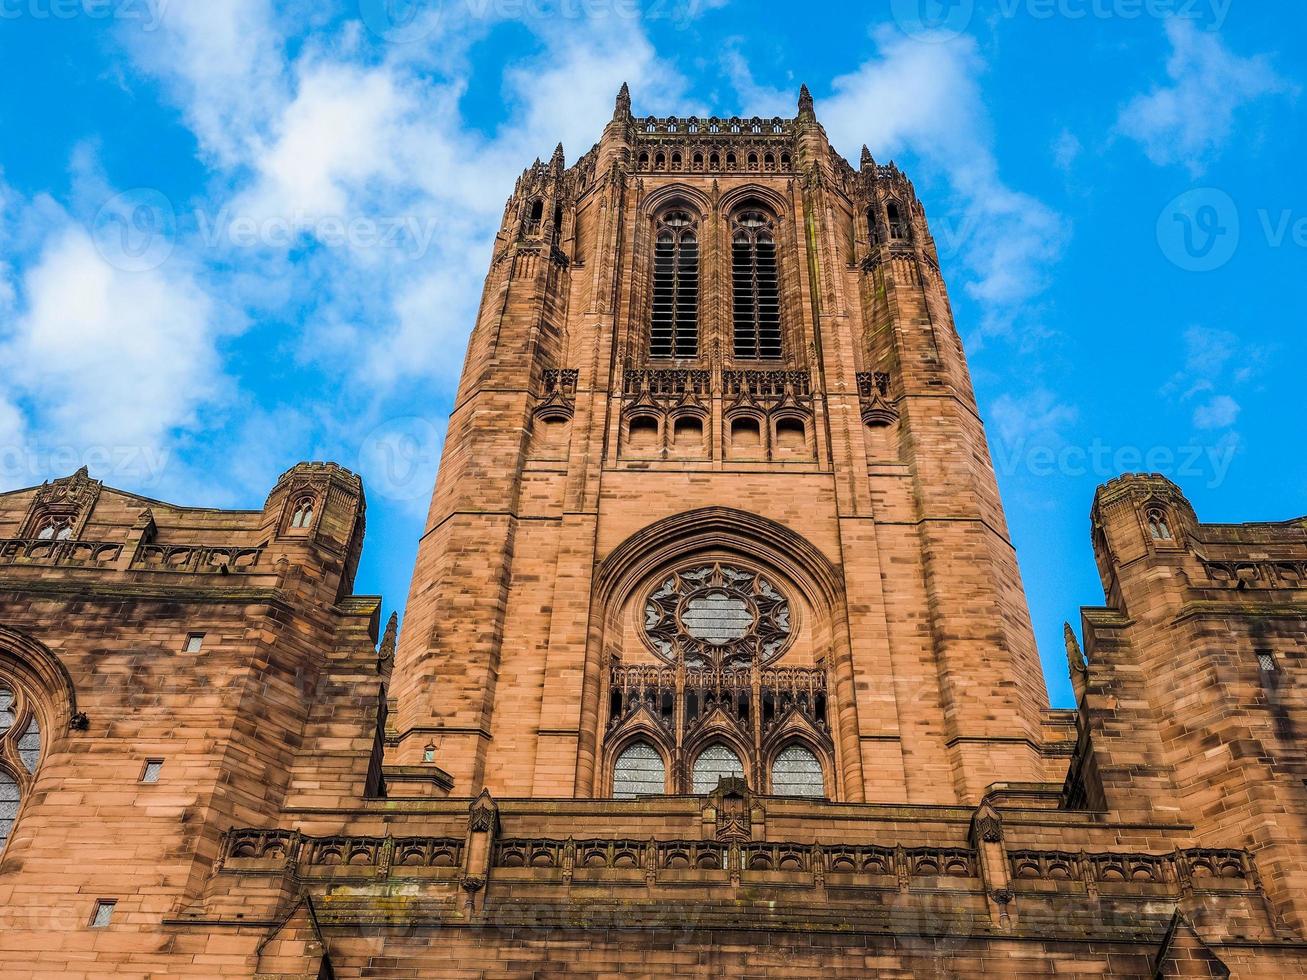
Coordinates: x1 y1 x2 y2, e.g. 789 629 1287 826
0 0 1307 704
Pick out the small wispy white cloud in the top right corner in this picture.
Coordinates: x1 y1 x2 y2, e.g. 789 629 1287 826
1116 17 1295 174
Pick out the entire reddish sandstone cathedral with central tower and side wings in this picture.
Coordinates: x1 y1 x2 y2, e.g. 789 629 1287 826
0 86 1307 977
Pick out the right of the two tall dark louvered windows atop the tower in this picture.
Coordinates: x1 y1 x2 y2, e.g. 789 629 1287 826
731 210 780 358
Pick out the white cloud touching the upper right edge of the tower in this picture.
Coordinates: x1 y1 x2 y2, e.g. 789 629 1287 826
817 29 1068 332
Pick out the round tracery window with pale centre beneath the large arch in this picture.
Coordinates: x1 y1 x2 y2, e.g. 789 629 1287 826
644 562 792 669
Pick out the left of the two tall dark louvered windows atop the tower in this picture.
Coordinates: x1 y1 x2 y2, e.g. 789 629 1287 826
650 210 699 358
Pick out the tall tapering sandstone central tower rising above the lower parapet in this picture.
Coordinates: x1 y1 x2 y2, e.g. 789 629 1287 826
392 86 1048 804
